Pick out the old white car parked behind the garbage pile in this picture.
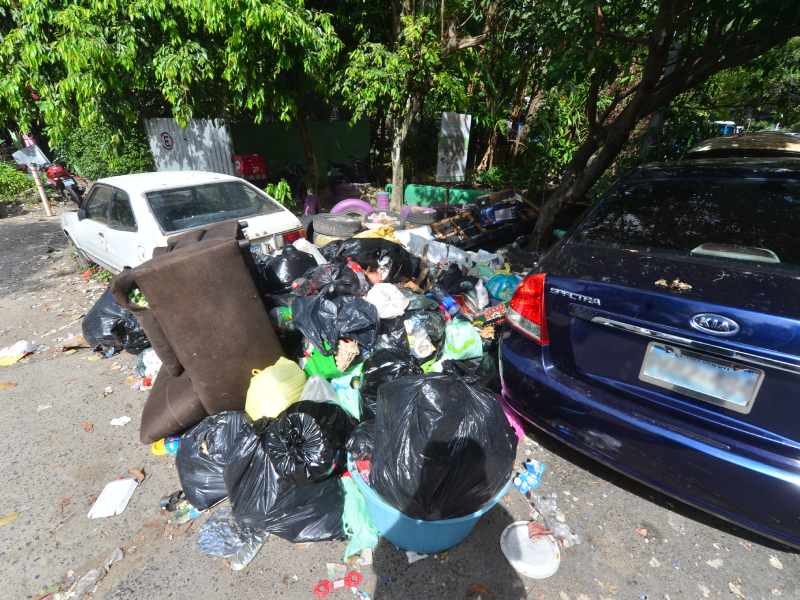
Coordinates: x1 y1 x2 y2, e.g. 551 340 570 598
61 171 303 273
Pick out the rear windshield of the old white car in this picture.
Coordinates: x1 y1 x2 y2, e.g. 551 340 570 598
146 181 283 233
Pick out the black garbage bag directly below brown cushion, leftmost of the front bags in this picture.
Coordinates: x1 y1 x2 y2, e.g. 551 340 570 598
175 411 253 510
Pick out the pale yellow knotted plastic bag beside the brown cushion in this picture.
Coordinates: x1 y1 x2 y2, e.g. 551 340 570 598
244 357 306 421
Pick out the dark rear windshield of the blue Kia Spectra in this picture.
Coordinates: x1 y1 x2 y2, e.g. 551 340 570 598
577 173 800 268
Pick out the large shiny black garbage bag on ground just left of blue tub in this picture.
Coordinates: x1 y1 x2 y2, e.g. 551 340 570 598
224 401 354 542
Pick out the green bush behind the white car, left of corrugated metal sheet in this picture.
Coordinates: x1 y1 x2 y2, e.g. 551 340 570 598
56 120 155 179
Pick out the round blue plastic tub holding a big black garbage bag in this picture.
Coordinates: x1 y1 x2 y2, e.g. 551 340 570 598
348 456 512 554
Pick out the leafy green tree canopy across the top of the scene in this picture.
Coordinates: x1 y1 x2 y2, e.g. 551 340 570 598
0 0 800 245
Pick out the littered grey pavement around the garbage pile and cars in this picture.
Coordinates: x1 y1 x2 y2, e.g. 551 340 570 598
0 204 800 600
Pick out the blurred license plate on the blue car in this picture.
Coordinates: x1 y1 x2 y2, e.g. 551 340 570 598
639 342 764 414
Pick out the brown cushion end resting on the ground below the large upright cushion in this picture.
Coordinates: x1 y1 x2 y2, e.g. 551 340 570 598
139 369 207 444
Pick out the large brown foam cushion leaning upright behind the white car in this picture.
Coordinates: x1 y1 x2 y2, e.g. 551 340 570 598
122 222 283 414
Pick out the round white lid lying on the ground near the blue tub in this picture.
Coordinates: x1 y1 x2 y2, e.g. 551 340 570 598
500 521 561 579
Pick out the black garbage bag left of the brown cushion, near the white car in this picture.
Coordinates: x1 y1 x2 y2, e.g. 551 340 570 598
81 288 150 354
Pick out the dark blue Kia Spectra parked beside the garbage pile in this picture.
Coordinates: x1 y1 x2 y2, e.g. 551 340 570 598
500 157 800 548
